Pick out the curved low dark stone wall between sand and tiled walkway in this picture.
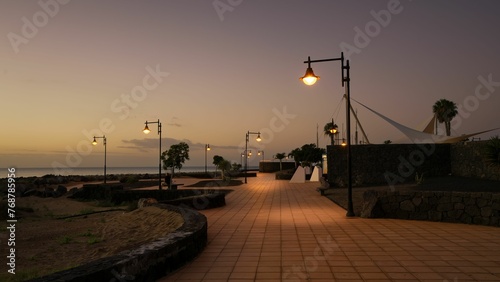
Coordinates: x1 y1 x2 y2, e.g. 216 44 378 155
31 204 207 282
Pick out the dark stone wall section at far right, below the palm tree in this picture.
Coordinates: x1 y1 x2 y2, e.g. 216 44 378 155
451 141 500 181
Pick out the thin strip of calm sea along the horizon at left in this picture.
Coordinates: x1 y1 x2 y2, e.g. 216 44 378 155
0 165 259 178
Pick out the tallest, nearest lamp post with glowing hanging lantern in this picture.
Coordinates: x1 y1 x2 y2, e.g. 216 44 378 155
300 52 354 217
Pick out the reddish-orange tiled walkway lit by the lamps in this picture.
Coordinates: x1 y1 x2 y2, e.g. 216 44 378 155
159 174 500 282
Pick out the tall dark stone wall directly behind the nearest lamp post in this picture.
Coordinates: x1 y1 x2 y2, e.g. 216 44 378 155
327 144 451 187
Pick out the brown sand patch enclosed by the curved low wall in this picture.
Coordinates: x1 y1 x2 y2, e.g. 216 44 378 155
0 197 184 281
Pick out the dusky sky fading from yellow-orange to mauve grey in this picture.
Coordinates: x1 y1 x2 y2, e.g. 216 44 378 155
0 0 500 171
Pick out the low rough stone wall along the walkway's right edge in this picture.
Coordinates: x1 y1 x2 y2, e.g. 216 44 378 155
360 190 500 226
